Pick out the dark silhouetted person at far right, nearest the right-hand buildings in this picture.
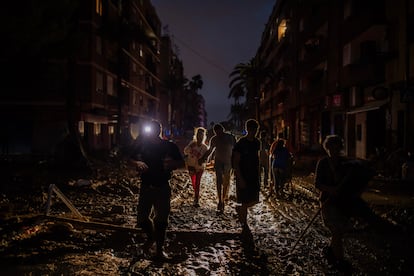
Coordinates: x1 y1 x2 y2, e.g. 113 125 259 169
315 135 389 271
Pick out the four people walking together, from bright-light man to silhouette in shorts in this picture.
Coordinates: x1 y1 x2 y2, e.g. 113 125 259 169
130 119 266 259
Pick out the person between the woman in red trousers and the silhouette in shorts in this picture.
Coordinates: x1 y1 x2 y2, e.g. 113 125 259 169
200 124 236 213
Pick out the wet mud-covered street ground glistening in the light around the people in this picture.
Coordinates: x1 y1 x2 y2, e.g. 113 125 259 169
0 161 414 275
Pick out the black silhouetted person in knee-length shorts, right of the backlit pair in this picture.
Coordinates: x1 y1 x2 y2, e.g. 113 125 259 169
233 119 260 234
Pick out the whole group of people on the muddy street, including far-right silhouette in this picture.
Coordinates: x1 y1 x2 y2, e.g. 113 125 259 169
131 119 382 272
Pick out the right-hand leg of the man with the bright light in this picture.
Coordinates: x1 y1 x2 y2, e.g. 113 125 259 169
154 187 171 258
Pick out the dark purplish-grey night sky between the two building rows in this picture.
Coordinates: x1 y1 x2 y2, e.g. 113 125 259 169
152 0 276 123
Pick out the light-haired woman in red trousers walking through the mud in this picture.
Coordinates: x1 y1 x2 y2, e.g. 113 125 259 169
184 127 208 207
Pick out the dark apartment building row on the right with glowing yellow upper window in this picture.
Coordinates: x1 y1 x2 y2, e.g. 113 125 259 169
257 0 414 159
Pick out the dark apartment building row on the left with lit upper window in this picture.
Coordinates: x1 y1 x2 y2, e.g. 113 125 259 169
0 0 187 154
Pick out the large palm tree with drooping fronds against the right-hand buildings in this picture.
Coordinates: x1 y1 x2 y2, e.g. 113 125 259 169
228 57 273 122
